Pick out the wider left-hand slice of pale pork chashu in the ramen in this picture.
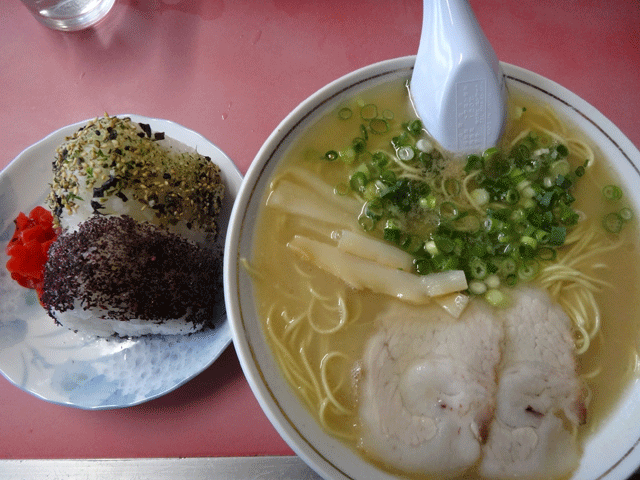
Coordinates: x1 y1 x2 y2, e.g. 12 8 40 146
360 303 502 476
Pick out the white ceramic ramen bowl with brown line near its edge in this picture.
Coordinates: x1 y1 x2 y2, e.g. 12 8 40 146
224 57 640 480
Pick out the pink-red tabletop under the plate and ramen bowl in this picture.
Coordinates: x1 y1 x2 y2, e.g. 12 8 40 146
0 0 640 459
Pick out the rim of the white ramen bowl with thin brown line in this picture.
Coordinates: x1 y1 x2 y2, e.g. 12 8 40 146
224 55 640 480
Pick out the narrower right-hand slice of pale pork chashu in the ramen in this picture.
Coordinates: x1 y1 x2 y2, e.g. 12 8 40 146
481 290 586 478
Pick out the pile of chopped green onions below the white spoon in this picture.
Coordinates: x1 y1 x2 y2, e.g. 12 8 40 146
322 105 588 304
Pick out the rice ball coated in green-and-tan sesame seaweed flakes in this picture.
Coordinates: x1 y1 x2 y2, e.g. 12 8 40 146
47 116 224 241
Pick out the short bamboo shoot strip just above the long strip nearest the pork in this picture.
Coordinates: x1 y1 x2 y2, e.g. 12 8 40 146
338 230 413 272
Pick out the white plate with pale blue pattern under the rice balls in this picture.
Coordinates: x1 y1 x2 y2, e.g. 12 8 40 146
0 115 242 410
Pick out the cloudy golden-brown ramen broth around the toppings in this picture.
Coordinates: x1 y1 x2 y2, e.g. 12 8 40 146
247 79 640 478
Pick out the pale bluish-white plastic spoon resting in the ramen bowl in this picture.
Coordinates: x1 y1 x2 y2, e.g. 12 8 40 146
410 0 506 154
